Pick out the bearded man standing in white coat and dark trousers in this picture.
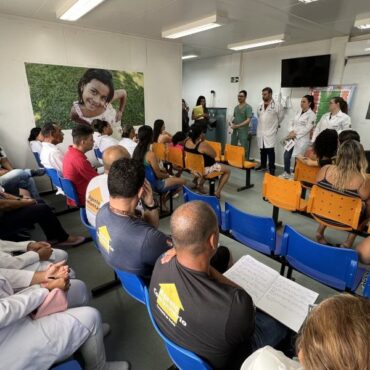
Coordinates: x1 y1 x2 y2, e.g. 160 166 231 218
256 87 284 175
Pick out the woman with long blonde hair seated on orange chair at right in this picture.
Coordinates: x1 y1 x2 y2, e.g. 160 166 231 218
316 140 370 248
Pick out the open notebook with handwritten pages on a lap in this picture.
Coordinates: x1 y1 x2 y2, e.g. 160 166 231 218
224 256 319 332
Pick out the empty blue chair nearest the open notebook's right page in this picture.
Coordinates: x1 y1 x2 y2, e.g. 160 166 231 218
281 225 365 292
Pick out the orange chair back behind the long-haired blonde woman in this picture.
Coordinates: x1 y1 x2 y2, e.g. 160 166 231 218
307 185 362 231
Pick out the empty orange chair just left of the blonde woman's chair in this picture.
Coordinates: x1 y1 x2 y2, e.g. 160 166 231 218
262 173 307 225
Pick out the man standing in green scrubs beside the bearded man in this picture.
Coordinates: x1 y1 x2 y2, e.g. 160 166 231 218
230 90 253 159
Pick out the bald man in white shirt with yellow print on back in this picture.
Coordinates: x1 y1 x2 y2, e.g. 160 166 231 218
86 145 130 227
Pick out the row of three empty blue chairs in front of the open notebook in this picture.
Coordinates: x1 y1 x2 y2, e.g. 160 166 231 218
184 187 370 292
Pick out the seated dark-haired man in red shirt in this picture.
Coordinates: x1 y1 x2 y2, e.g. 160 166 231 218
63 124 98 207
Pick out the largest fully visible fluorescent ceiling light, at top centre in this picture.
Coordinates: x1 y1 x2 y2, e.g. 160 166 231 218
162 14 225 39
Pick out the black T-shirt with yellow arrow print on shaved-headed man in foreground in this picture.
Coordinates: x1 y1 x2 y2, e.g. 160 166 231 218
149 258 255 370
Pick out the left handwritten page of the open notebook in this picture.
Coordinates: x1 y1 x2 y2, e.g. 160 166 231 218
224 256 280 305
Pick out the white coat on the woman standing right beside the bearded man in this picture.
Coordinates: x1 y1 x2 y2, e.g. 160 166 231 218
288 108 316 157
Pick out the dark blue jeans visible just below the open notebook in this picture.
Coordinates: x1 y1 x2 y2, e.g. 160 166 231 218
251 311 289 352
